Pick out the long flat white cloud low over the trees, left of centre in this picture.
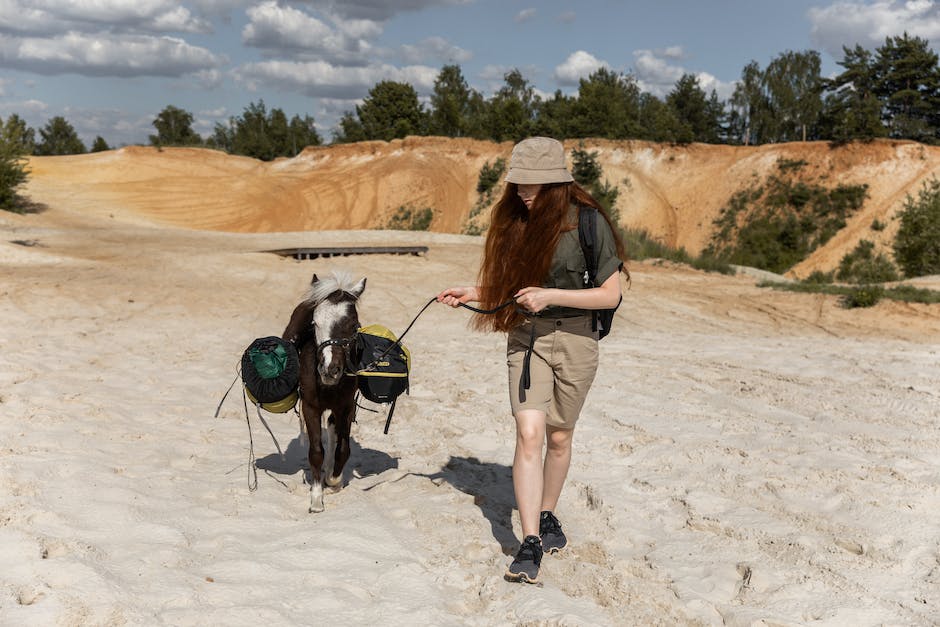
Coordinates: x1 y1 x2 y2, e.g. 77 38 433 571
233 60 438 99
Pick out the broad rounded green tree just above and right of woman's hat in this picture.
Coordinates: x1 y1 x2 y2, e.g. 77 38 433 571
569 67 640 139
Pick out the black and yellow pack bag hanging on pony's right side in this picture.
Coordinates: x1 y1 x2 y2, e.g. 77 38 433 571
356 324 411 403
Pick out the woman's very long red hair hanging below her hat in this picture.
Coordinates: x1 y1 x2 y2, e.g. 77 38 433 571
473 183 626 331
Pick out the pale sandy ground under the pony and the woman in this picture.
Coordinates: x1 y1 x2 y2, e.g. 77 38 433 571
0 202 940 626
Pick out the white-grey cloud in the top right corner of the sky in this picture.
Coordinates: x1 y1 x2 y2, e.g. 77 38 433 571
807 0 940 59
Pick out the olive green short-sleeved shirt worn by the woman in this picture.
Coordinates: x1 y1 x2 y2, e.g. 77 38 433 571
542 206 623 318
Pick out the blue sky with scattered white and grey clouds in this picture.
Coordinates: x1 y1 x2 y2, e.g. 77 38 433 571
0 0 940 147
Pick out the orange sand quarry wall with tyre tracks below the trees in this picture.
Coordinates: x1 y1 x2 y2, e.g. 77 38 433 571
20 137 940 276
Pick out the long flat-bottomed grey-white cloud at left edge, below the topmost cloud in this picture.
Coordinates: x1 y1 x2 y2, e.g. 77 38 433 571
0 32 226 77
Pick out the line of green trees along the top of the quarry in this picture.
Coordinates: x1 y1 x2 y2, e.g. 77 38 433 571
0 33 940 211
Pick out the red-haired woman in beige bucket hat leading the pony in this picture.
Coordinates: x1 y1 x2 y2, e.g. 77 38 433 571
437 137 625 583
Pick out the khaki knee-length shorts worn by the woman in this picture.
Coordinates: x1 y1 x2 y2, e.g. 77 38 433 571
506 316 597 429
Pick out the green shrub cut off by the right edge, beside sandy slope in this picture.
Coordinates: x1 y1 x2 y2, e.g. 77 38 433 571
894 179 940 277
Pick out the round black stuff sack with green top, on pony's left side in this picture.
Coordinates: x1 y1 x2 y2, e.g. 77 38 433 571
242 336 300 414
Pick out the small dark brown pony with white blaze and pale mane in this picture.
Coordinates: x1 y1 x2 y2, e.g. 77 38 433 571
282 271 366 513
